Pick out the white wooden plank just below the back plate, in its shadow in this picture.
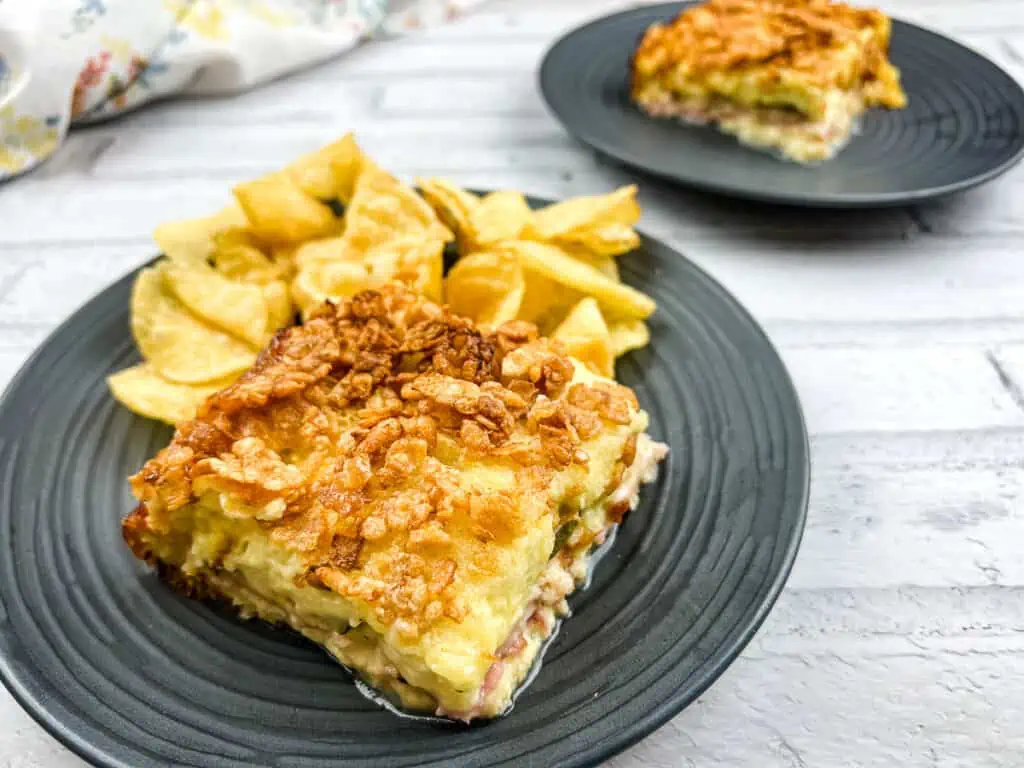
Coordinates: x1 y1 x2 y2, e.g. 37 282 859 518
663 231 1024 325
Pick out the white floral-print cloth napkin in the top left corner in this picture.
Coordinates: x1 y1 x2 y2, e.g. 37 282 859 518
0 0 482 181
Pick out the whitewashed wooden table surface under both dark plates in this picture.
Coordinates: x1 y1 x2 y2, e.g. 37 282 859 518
0 0 1024 768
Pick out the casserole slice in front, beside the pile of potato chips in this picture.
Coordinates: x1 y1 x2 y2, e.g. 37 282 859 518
123 285 667 721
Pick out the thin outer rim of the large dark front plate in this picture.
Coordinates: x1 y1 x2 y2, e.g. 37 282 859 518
0 201 812 768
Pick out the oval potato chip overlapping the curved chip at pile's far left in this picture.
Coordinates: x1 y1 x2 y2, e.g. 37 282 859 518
163 263 269 346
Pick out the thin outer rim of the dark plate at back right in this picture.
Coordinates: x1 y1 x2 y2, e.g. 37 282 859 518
536 0 1024 210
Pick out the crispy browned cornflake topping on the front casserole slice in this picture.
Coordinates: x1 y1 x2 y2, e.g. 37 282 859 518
132 286 637 639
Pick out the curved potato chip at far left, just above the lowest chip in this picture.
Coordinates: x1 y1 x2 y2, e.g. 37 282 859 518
131 261 256 384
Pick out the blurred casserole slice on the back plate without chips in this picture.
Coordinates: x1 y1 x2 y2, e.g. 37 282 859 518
632 0 906 163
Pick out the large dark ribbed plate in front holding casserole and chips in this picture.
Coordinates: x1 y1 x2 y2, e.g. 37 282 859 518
0 205 808 768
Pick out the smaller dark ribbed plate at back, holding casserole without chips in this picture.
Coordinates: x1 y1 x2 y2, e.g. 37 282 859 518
540 3 1024 208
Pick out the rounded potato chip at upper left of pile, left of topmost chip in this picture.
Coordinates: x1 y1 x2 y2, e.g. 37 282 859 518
234 173 341 244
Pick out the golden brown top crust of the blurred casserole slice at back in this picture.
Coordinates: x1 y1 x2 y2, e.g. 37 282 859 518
633 0 905 109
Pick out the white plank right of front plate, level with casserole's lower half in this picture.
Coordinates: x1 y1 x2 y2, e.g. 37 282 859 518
788 462 1024 589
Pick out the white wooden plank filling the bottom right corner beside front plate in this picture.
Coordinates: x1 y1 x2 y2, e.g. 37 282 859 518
608 650 1024 768
